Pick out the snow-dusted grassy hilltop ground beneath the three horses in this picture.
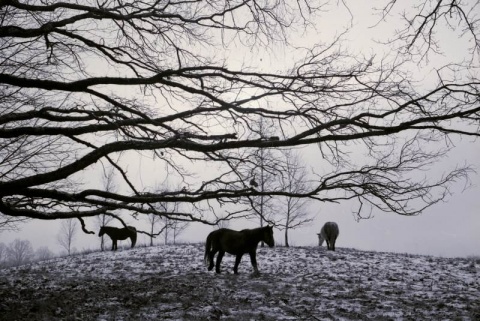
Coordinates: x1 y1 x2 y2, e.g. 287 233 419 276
0 244 480 320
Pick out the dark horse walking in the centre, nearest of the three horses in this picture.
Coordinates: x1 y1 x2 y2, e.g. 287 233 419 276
204 226 275 274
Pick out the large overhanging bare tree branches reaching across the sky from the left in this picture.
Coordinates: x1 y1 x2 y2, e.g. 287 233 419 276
0 0 480 230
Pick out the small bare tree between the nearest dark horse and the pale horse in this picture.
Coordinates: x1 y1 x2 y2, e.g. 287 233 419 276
276 150 313 247
